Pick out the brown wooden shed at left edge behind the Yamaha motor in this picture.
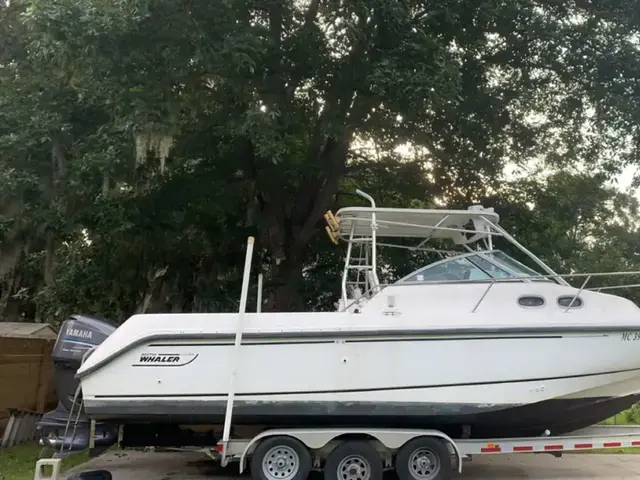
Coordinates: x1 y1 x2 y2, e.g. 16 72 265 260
0 322 58 435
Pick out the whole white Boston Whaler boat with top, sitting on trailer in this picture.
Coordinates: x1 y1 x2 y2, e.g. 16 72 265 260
42 192 640 444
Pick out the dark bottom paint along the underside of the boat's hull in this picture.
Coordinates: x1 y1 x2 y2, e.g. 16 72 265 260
86 395 640 438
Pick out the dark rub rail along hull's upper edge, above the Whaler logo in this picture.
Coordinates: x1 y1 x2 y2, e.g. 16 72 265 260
76 325 640 378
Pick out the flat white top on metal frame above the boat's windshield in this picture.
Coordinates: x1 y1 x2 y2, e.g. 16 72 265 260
335 206 500 243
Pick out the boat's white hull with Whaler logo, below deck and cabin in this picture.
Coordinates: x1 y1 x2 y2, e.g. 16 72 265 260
78 314 640 437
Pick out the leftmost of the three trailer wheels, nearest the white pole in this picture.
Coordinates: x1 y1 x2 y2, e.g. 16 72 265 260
251 436 311 480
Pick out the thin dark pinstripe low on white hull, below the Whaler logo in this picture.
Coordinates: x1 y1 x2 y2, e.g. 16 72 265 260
95 368 640 399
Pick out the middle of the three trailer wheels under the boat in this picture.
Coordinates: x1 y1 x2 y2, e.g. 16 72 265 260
324 440 382 480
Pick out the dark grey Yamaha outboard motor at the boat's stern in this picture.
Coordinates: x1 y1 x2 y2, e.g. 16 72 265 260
38 315 118 452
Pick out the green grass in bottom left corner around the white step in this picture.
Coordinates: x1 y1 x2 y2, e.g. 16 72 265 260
0 443 89 480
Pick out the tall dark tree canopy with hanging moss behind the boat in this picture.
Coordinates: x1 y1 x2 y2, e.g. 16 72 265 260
0 0 640 321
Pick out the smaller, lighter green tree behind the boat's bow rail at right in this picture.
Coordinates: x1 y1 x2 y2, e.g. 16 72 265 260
483 170 640 302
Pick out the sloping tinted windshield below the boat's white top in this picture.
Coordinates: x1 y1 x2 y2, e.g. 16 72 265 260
398 250 552 283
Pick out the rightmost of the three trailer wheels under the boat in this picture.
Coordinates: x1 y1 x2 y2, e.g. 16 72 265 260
396 437 451 480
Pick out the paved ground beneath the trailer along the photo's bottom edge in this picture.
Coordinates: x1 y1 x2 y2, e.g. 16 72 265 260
65 451 640 480
